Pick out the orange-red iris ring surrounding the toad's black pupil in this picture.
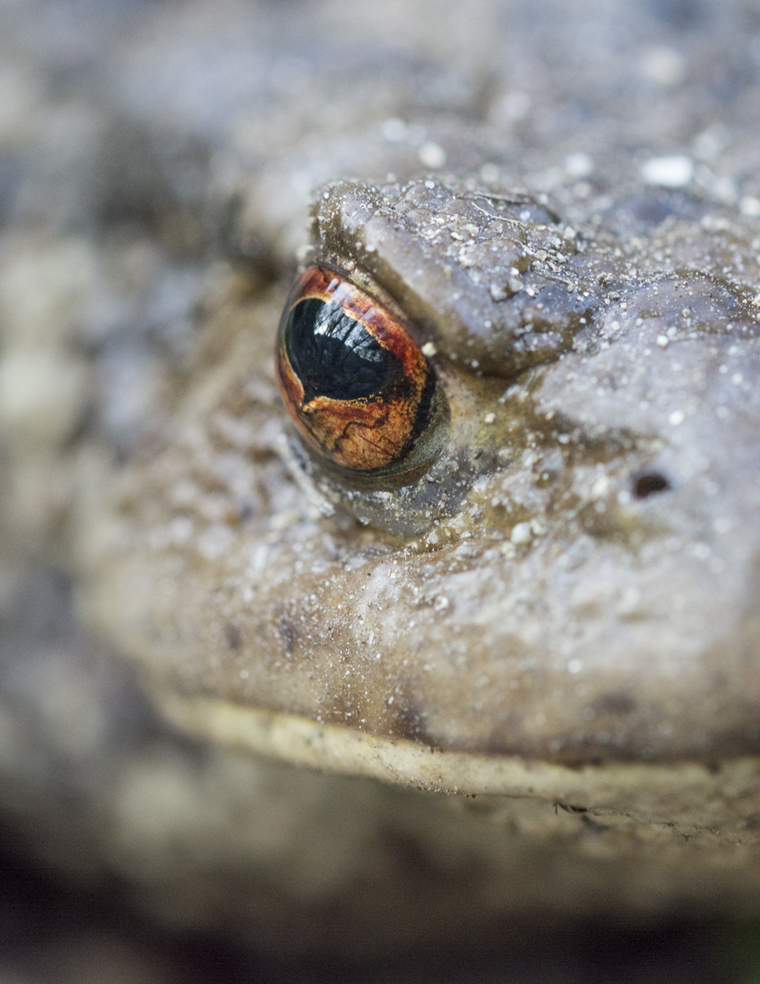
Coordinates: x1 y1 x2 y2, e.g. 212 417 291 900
276 267 430 472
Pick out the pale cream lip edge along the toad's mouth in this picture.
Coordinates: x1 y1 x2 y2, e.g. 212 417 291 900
154 691 760 844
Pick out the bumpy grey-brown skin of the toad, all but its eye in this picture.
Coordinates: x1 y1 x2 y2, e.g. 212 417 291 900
5 2 760 950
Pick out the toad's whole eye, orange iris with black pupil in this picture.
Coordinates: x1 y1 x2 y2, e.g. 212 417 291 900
275 267 447 475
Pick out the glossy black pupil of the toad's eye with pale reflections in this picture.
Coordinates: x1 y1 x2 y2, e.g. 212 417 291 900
285 297 398 403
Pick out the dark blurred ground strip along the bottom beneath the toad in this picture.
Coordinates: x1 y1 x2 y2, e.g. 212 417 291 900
0 845 760 984
